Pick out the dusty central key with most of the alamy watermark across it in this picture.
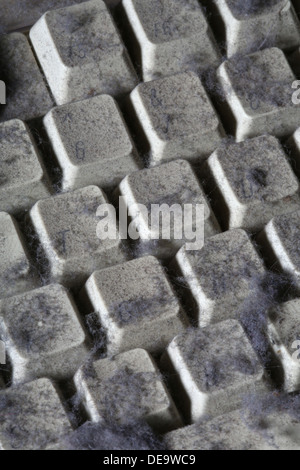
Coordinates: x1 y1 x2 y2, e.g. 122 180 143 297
119 160 220 258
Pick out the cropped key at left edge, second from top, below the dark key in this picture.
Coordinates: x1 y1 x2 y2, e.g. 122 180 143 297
0 119 51 213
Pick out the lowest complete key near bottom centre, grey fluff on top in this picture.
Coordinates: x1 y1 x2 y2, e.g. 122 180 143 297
75 349 181 433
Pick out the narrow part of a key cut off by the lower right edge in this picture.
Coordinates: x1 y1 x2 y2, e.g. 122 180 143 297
268 299 300 393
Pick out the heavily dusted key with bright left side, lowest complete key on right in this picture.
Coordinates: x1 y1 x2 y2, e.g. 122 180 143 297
162 320 267 422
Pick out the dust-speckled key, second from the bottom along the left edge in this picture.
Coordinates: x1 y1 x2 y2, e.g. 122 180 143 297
0 284 88 383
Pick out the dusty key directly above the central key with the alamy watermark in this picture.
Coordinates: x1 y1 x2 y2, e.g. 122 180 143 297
130 72 224 166
